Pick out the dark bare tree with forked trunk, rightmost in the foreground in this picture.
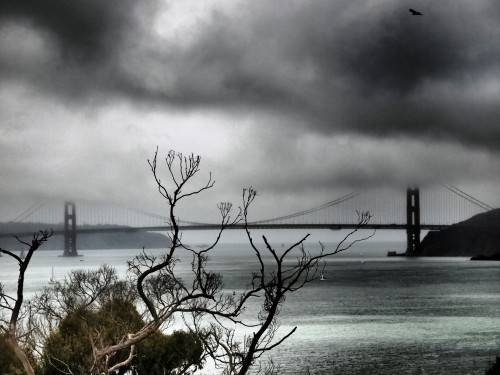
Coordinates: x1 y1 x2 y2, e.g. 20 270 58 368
193 188 374 375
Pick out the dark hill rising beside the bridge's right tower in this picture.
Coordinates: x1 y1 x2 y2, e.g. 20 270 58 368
418 208 500 257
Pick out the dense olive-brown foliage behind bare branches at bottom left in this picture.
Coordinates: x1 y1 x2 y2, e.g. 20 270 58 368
42 290 203 375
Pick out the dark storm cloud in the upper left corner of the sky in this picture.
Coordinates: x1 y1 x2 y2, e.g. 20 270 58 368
0 0 155 104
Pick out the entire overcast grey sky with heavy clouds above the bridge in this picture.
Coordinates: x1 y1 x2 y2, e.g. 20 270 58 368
0 0 500 226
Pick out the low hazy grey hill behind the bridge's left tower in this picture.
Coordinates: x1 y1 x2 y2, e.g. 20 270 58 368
0 222 171 250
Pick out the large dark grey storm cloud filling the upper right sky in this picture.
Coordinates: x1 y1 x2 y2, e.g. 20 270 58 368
175 1 500 149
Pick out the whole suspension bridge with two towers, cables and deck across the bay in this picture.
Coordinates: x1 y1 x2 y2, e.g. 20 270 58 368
0 185 492 256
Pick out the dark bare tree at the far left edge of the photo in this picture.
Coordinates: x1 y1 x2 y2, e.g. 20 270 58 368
0 231 52 375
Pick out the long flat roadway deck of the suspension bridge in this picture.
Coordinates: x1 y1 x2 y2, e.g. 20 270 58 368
0 223 450 238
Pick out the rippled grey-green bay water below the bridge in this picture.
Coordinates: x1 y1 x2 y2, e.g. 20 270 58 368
0 245 500 375
